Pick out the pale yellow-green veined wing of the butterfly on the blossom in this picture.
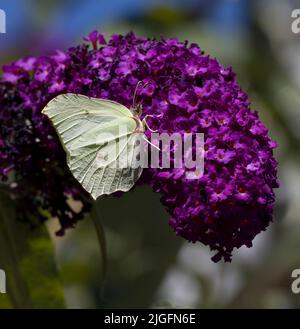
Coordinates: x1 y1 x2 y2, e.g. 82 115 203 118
43 94 142 199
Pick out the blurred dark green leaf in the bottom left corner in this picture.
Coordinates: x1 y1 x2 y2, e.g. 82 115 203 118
0 192 65 308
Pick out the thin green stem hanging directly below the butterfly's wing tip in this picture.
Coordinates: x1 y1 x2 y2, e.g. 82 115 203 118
90 202 107 279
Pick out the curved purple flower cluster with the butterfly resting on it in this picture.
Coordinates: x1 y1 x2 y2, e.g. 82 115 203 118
0 32 278 261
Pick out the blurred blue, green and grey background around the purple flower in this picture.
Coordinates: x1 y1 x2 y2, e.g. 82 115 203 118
0 0 300 308
